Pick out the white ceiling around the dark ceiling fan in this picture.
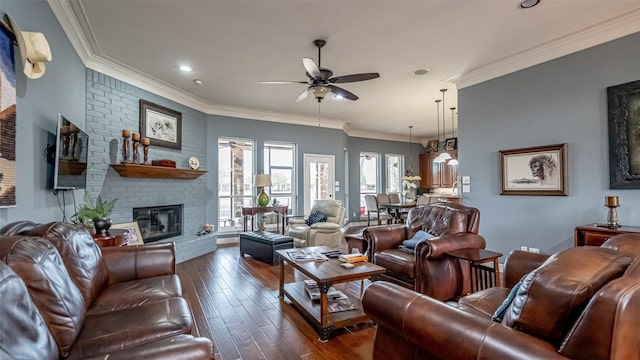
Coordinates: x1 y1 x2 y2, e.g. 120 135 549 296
49 0 640 141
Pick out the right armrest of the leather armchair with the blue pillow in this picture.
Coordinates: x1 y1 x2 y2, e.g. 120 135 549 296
416 233 486 259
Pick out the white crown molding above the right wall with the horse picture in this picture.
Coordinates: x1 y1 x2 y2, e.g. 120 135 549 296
446 9 640 90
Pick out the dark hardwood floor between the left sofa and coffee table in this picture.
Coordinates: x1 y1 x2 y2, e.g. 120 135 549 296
177 245 375 360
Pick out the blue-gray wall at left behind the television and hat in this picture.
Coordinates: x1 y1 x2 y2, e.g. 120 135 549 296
0 0 85 223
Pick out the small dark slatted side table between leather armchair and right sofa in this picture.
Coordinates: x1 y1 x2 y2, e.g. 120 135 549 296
447 248 502 292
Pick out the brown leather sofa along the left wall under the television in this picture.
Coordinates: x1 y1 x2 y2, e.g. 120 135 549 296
0 221 213 359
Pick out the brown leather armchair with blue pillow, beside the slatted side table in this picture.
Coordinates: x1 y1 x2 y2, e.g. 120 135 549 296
363 202 485 301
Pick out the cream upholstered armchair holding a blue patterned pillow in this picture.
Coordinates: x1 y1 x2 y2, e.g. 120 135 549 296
285 199 344 247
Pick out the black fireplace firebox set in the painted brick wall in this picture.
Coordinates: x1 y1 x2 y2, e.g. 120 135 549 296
133 205 182 243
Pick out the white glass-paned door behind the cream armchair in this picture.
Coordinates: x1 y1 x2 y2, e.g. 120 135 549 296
303 154 336 214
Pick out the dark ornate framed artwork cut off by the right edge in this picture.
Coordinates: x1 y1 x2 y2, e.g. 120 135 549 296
607 80 640 189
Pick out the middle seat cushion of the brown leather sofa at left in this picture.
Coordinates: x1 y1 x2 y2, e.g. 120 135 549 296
69 298 192 359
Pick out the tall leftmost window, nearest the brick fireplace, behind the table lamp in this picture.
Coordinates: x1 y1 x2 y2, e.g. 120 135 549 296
218 138 254 229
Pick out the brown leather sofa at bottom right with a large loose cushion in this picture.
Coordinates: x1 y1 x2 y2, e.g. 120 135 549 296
362 235 640 360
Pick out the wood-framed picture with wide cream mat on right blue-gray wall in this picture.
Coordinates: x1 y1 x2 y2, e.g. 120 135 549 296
500 144 569 196
